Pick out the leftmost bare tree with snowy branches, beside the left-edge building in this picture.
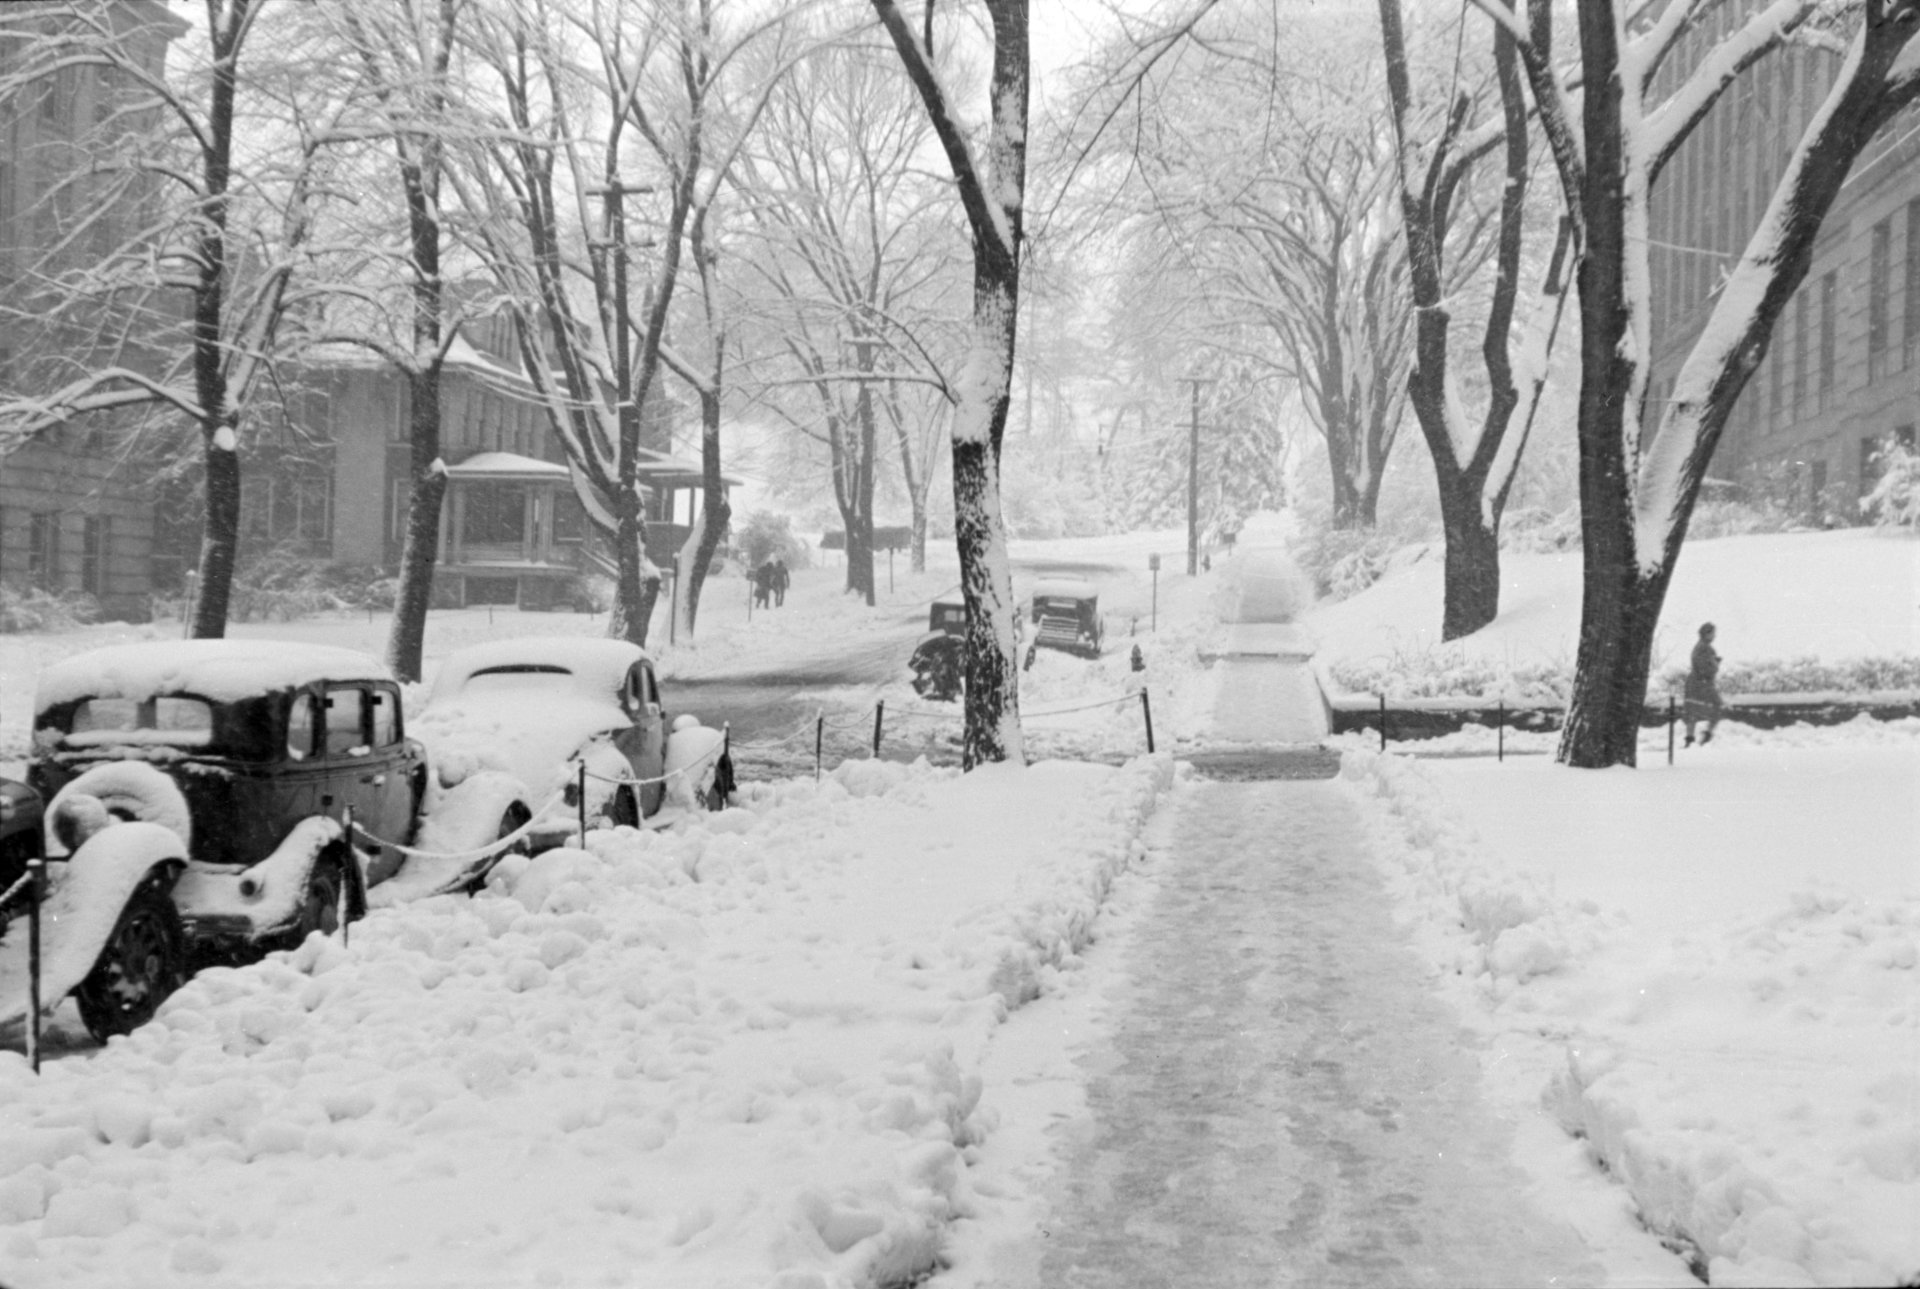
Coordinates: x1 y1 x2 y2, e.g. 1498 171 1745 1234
0 0 334 638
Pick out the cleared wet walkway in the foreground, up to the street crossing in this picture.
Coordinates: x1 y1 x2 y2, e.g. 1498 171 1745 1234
1035 782 1605 1289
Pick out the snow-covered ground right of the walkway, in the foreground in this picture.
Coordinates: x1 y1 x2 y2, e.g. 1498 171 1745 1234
1342 745 1920 1285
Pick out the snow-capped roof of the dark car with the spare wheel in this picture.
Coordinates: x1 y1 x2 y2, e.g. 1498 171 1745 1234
33 640 394 713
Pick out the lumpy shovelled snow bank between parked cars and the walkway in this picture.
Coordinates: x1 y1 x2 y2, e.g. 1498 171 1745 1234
0 759 1171 1289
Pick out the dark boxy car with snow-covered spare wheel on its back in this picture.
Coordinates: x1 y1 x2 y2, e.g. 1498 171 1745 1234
15 640 528 1039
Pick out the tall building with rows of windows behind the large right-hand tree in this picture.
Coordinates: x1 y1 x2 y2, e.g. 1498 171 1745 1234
1649 0 1920 523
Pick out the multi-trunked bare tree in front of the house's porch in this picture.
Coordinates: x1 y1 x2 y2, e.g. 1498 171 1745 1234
457 0 787 644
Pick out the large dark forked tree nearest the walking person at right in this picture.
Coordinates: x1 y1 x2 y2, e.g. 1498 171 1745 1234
1476 0 1920 766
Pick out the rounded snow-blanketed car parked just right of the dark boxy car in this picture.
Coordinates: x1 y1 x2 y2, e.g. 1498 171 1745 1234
417 636 733 849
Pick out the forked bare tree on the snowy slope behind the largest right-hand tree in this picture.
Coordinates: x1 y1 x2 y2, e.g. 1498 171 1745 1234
1380 0 1565 640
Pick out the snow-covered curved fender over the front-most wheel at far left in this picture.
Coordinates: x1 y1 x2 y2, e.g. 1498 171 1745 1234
0 822 186 1022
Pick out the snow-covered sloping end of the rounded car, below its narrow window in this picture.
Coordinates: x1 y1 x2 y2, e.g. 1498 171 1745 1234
411 693 630 809
